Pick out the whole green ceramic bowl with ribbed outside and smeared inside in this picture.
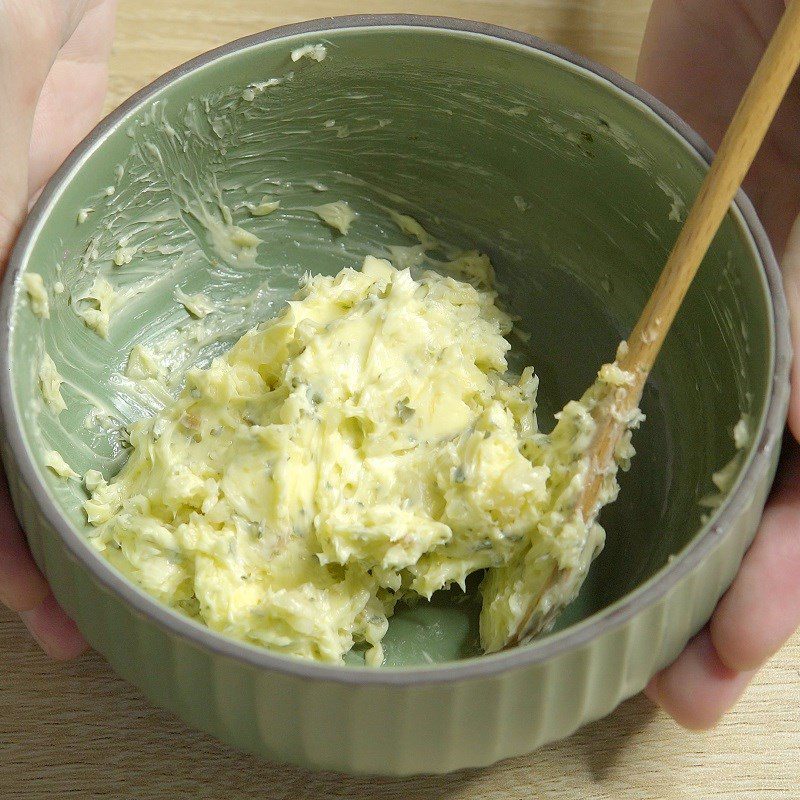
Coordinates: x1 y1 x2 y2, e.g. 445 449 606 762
0 16 789 774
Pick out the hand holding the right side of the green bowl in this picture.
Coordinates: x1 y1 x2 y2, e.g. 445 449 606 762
638 0 800 729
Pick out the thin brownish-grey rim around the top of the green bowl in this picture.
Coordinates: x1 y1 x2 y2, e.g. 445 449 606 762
0 14 791 686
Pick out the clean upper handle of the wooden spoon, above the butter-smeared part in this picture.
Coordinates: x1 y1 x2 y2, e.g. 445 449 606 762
619 0 800 386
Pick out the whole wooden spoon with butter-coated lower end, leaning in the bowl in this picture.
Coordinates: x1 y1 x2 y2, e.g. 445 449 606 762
506 0 800 648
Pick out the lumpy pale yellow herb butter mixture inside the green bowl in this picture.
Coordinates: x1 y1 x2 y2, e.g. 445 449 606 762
83 256 632 665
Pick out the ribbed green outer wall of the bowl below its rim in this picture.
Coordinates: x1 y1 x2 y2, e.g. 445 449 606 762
4 432 778 775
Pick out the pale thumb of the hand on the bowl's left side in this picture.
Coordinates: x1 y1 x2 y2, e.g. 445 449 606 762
0 0 83 272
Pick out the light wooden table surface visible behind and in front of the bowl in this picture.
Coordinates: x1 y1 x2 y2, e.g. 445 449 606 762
0 0 800 800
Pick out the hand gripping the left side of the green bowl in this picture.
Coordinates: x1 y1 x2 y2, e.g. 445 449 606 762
0 0 116 658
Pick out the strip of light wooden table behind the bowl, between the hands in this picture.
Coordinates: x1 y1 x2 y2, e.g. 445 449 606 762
101 0 650 110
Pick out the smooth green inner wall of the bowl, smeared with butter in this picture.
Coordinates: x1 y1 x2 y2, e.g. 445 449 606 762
10 27 772 664
